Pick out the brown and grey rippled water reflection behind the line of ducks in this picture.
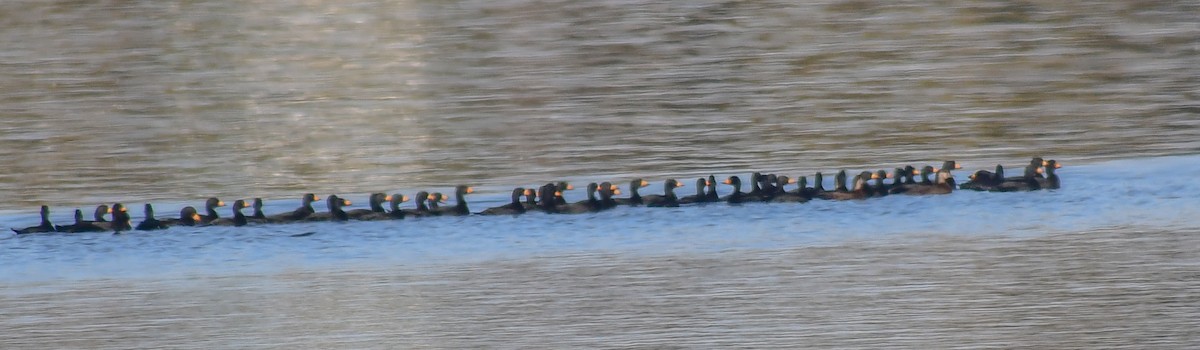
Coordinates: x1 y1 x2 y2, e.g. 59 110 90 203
0 0 1200 209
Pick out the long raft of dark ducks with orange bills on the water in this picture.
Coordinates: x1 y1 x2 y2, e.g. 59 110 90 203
12 157 1062 234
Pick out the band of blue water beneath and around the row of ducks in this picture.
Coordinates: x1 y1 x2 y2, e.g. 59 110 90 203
0 156 1200 283
